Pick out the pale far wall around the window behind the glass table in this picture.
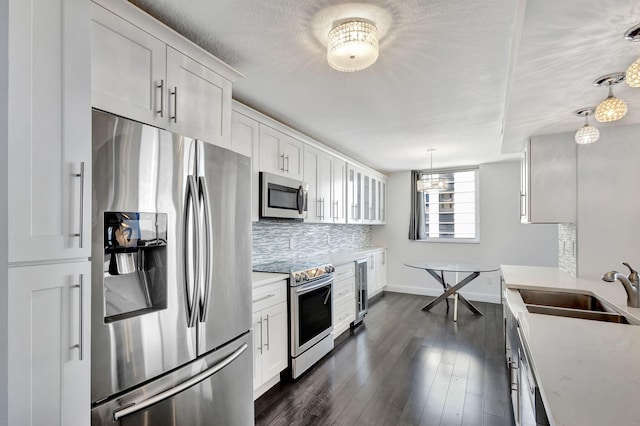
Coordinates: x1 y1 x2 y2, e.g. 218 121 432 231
373 161 558 303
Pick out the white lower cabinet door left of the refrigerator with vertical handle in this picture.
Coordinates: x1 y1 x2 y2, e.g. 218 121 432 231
8 261 91 426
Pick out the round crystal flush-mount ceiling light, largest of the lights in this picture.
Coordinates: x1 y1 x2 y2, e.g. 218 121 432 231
327 19 378 72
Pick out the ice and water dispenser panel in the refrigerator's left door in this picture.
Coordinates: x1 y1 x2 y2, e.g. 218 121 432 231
104 212 167 323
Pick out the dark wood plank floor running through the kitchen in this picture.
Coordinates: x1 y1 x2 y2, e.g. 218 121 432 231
255 293 514 426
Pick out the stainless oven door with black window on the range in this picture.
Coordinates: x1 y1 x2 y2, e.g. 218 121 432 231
291 276 333 358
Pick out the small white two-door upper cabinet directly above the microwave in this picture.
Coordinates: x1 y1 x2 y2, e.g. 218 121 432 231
260 123 304 180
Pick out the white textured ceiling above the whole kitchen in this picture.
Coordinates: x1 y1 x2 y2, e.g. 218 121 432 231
130 0 640 171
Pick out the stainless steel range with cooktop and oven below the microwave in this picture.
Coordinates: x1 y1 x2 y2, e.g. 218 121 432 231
253 262 334 379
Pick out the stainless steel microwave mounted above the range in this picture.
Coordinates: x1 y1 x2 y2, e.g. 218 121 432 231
260 172 307 220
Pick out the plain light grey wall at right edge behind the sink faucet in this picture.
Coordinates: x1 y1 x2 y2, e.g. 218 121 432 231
577 125 640 280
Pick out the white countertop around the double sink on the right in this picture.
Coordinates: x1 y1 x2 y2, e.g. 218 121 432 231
501 265 640 426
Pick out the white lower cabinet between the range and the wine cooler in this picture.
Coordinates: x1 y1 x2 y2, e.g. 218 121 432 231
333 262 356 339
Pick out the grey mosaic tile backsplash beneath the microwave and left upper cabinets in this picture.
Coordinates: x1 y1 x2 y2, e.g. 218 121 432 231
252 220 371 265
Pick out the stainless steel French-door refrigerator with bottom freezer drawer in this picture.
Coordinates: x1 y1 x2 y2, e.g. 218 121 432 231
91 110 253 426
